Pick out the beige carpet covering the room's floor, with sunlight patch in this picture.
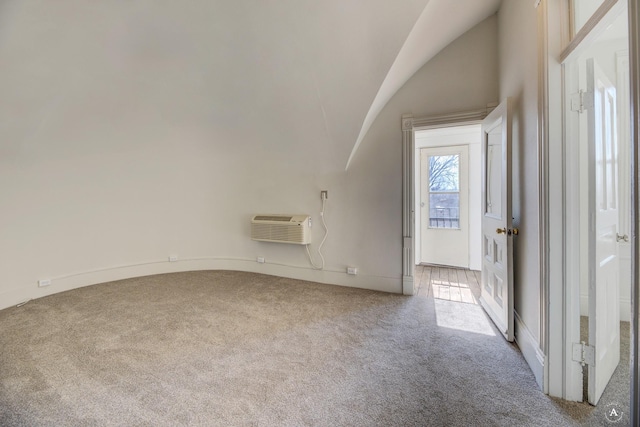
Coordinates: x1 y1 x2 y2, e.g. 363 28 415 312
0 271 612 426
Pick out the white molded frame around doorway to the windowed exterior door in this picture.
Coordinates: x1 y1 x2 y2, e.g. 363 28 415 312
401 108 498 295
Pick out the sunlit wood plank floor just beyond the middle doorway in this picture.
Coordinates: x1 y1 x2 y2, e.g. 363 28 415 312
415 265 480 304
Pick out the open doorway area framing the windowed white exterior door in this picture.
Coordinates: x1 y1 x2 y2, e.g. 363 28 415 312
414 124 482 270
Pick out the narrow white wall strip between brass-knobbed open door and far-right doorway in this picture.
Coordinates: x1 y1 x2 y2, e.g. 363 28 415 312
498 1 543 385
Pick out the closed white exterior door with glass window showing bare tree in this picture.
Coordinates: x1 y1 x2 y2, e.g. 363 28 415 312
420 146 469 268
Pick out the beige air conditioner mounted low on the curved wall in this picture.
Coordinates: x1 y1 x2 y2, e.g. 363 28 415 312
251 214 311 245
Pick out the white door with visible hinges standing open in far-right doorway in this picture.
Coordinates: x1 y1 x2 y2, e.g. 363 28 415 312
586 59 620 405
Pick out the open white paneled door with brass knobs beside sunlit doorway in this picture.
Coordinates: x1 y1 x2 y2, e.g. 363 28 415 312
480 99 518 341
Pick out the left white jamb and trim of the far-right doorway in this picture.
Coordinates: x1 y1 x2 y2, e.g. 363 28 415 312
537 0 624 401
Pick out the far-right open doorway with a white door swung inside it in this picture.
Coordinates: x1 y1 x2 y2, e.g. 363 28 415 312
563 0 632 407
